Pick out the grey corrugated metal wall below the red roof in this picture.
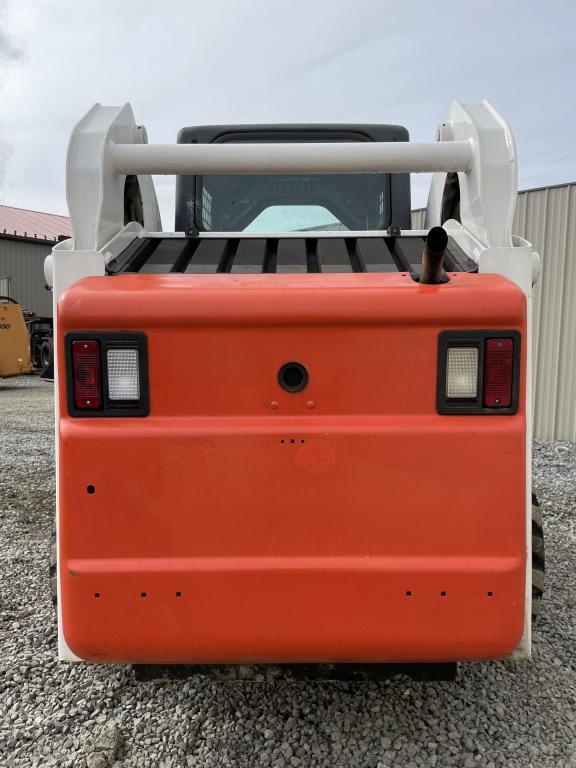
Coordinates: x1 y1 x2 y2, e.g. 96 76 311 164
0 237 52 317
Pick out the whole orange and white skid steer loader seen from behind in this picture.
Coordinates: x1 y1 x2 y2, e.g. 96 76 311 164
46 102 543 679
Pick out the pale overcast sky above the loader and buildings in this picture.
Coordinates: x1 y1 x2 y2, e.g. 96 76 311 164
0 0 576 229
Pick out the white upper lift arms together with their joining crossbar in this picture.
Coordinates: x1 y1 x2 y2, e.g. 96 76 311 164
67 101 517 251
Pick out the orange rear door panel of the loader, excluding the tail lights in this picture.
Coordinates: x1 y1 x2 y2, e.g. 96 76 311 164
58 273 525 663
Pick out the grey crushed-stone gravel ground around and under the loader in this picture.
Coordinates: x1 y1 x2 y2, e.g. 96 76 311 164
0 377 576 768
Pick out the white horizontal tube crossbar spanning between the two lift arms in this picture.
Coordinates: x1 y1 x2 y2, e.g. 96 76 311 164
110 139 473 175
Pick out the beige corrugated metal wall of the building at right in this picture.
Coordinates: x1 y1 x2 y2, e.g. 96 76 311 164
412 184 576 442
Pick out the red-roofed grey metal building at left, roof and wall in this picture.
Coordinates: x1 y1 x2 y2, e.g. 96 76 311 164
0 205 72 317
